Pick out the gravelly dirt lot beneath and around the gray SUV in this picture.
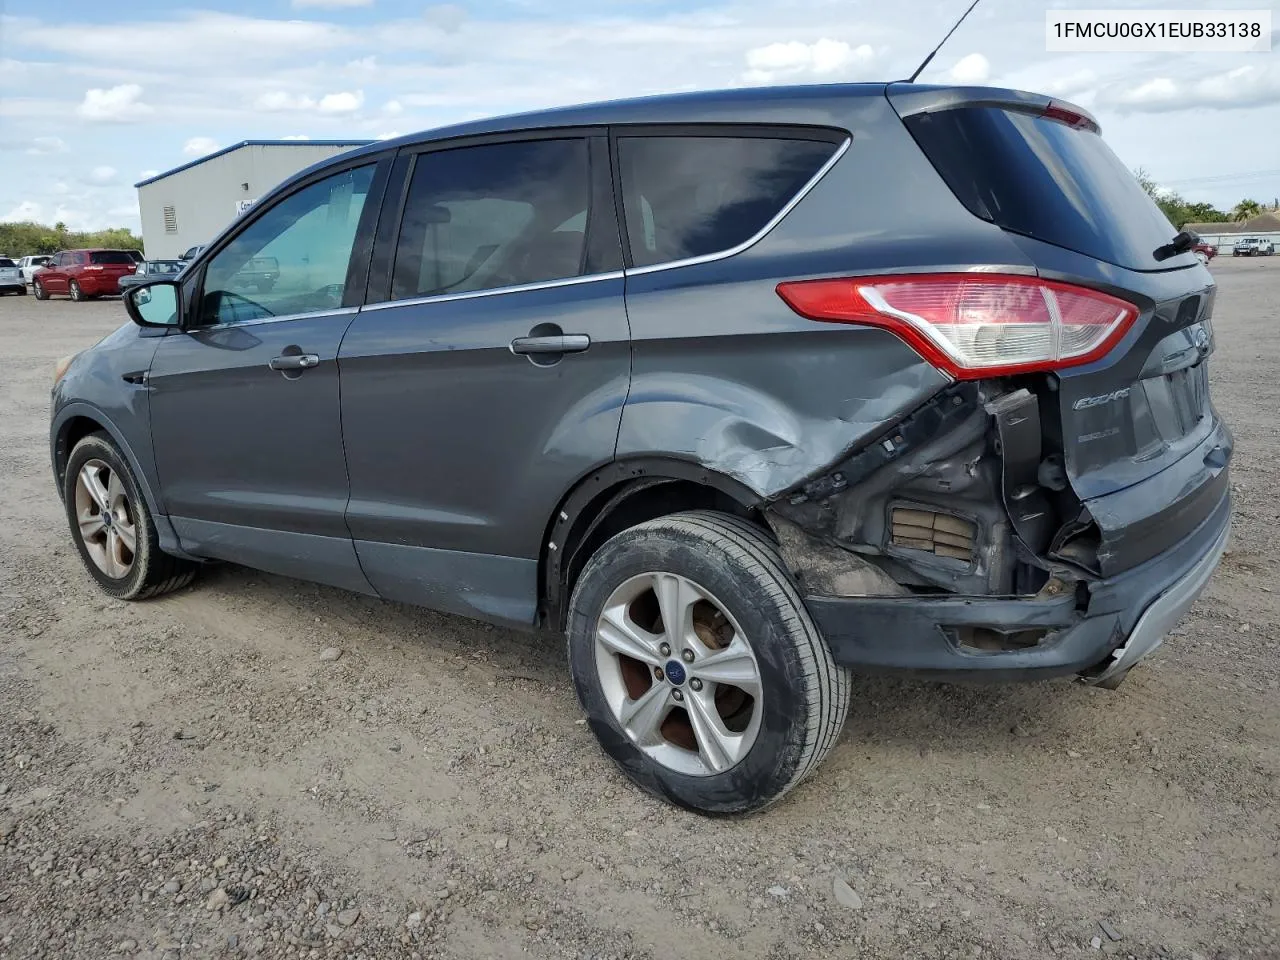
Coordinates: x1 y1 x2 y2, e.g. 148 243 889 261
0 257 1280 960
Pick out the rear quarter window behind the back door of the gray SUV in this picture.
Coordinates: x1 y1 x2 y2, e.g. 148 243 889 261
618 136 837 266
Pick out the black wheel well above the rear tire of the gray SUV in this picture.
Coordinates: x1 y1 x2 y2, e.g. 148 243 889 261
539 463 772 631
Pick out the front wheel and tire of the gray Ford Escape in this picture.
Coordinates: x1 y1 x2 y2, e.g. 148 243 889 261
63 433 196 600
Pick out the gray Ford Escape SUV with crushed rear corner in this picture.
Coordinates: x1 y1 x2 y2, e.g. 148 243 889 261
51 83 1231 813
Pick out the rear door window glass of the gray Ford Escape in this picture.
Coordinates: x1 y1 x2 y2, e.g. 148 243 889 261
392 140 590 300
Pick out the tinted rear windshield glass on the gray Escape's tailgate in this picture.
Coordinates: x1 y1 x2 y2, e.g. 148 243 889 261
906 106 1176 269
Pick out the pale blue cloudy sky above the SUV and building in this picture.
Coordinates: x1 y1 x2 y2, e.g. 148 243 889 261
0 0 1280 229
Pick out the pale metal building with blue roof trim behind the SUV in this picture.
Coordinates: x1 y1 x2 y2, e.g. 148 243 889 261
133 140 370 260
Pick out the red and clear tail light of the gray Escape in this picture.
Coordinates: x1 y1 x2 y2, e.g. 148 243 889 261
778 274 1138 380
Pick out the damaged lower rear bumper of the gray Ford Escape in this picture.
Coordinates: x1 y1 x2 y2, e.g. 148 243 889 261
805 490 1231 682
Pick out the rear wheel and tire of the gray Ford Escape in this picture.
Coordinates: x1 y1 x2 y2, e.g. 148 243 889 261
567 511 850 814
